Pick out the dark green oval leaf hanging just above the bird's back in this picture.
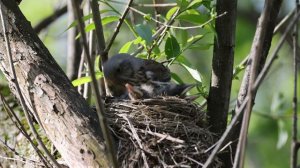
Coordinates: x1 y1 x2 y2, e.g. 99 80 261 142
165 35 181 59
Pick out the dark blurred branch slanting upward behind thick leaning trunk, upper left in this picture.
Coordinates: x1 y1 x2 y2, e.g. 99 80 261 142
33 5 67 34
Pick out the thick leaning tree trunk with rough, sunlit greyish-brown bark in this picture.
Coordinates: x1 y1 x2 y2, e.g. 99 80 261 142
0 0 109 167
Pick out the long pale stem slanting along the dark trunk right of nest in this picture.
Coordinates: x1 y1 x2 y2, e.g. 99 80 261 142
233 0 282 168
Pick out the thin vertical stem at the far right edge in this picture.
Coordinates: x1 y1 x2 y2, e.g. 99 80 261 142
290 0 300 168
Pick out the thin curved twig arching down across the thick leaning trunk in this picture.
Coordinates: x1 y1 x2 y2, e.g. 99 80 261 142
0 3 60 168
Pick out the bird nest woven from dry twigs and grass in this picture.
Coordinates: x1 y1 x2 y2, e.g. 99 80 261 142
106 97 222 167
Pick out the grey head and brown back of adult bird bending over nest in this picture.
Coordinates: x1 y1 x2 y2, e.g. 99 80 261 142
103 53 171 97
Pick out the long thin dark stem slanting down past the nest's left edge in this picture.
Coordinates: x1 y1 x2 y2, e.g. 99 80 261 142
72 0 118 168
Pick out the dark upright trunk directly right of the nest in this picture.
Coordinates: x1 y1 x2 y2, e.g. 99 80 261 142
207 0 237 135
